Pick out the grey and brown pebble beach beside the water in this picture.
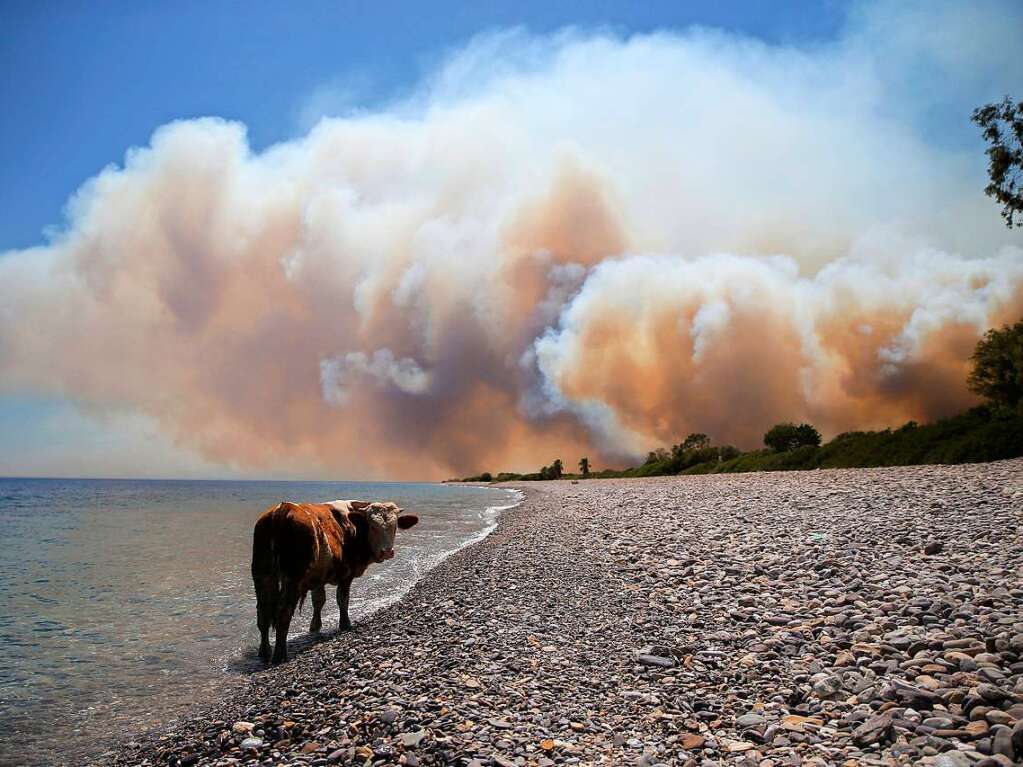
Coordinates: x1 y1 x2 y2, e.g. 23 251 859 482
100 460 1023 767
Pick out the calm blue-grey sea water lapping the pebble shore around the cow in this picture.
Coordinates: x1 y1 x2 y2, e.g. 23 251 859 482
0 480 517 764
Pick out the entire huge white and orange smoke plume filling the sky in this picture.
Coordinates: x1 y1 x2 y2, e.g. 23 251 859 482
0 4 1023 478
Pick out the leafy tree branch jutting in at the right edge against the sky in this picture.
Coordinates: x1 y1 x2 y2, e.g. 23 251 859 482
973 96 1023 227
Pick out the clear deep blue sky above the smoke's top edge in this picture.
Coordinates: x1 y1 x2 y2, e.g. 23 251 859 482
0 0 843 251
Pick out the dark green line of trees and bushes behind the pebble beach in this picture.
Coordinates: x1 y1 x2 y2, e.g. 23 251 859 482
451 320 1023 482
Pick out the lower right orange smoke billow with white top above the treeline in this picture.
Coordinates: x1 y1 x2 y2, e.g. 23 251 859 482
530 246 1023 445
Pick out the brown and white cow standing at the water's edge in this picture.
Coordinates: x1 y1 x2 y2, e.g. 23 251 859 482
252 501 419 663
